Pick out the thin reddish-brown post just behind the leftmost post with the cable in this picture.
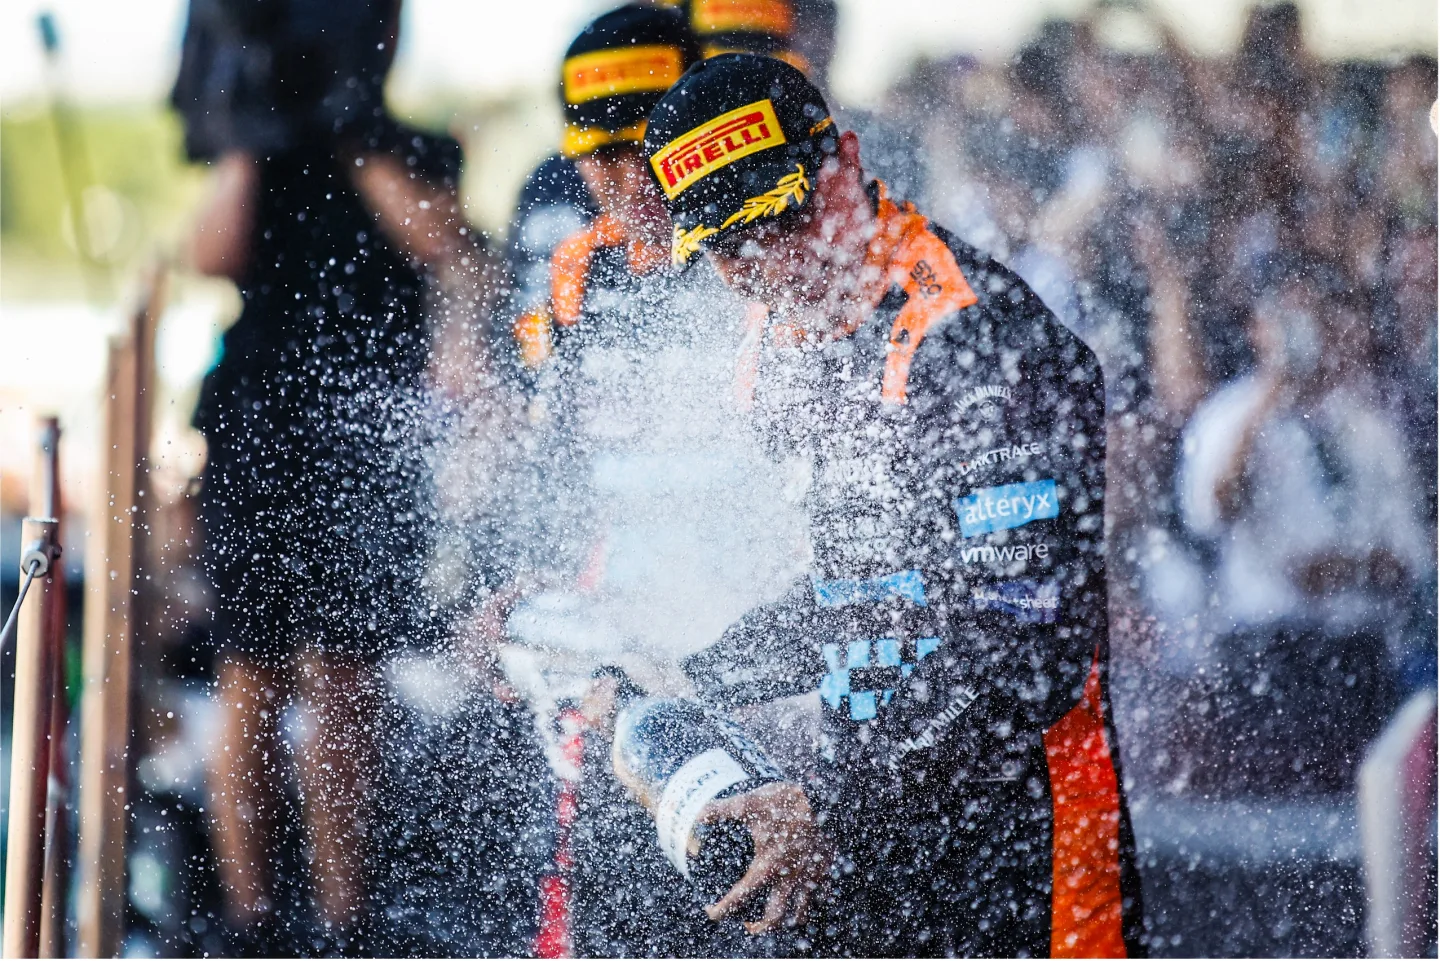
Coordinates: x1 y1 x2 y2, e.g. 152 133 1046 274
30 416 72 958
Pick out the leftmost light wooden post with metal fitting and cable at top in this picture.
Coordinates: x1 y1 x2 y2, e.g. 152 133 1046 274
4 517 59 958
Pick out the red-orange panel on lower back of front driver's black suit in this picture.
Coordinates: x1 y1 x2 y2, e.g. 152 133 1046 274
1045 656 1126 958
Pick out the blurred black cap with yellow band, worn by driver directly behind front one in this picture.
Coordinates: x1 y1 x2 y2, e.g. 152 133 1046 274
560 3 700 157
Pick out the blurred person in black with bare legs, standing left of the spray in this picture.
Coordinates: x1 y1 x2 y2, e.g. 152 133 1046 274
173 0 490 954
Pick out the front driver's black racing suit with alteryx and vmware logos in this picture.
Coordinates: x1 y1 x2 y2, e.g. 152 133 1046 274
687 184 1139 957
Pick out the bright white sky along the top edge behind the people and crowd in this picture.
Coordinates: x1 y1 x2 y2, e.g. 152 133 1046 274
0 0 1437 109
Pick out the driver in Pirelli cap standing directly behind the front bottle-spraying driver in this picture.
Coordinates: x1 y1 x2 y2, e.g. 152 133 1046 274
480 3 700 625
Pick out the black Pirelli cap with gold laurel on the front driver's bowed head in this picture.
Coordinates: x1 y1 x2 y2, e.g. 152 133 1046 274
645 53 835 264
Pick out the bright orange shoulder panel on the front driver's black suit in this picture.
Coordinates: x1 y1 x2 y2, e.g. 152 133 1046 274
880 228 979 403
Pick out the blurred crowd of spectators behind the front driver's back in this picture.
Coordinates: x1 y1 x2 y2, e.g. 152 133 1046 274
864 3 1436 792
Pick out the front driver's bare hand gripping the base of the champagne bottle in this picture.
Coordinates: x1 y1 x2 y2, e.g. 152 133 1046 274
700 782 829 934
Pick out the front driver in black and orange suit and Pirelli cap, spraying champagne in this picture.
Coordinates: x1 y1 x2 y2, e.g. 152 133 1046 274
645 55 1140 957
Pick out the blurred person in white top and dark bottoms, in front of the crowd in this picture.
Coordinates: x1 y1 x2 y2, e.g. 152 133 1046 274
1178 270 1434 795
